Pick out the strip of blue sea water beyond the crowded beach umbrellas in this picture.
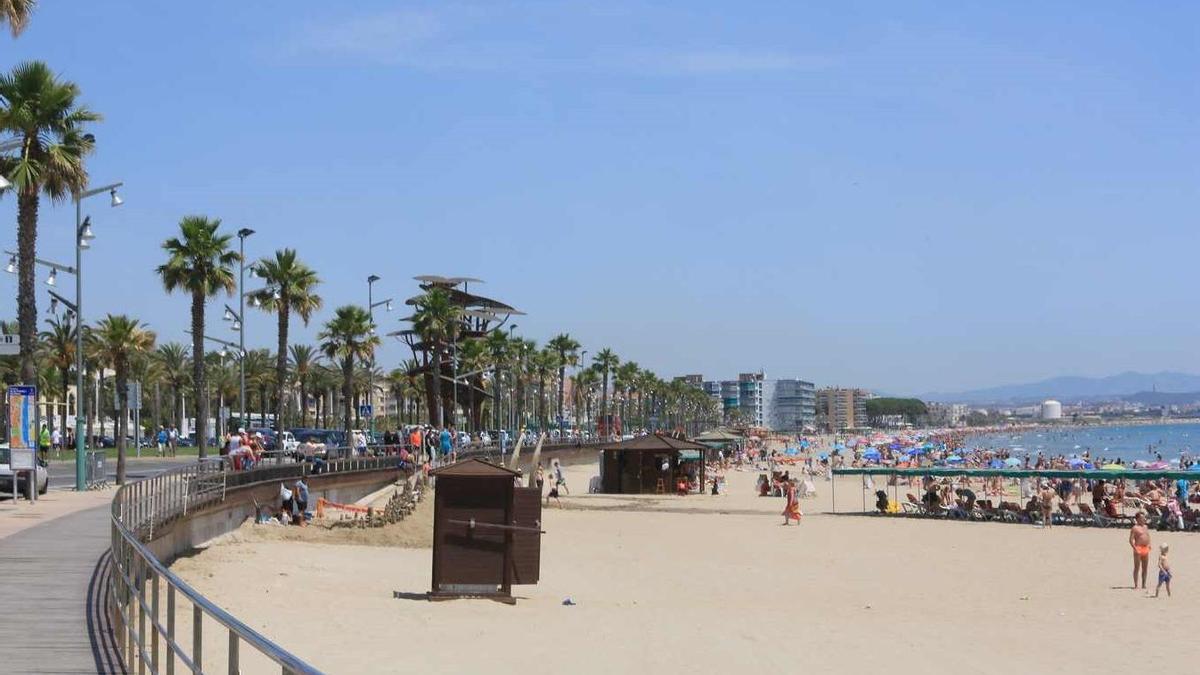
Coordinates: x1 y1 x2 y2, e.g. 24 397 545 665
967 424 1200 462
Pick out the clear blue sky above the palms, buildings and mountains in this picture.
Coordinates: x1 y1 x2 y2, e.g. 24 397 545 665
0 0 1200 392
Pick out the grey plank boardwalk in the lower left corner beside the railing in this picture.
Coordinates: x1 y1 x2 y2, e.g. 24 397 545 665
0 506 125 673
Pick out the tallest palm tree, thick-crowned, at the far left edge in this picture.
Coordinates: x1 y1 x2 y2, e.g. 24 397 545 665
0 61 100 382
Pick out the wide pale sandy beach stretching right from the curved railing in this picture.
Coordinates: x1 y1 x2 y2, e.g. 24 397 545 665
173 456 1200 674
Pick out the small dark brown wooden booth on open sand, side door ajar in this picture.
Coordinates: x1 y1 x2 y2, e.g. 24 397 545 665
430 459 542 604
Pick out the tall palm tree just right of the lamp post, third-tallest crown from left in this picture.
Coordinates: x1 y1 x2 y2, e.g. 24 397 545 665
254 249 320 431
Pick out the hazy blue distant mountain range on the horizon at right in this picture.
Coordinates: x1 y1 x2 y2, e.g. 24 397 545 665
919 371 1200 405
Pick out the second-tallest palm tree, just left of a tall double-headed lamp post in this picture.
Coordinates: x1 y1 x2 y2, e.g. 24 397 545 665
157 216 237 459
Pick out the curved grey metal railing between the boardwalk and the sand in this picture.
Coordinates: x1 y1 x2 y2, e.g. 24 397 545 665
108 446 396 675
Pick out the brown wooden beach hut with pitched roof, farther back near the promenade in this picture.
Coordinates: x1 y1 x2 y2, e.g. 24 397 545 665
600 434 708 495
